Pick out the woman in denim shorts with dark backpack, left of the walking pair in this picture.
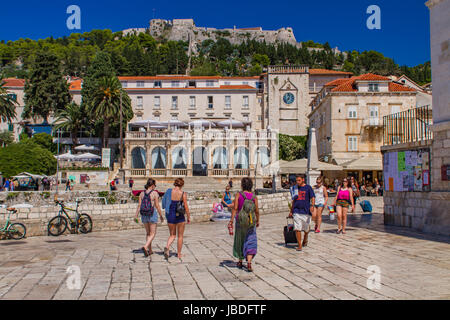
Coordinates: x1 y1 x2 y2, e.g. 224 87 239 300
136 178 164 257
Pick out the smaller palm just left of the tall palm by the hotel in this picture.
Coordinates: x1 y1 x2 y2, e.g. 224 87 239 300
54 102 85 149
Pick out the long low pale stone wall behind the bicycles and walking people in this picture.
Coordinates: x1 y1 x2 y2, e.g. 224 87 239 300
0 192 290 237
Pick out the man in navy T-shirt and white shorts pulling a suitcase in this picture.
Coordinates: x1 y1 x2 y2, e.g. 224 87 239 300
289 175 315 251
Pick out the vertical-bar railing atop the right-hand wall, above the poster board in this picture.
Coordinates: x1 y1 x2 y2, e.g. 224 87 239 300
383 105 433 146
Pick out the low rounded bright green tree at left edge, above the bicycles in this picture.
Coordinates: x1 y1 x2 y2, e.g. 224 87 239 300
0 139 56 177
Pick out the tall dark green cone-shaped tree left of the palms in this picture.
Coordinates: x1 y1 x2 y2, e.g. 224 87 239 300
22 51 72 122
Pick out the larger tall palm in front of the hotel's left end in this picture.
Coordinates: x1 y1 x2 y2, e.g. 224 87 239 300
89 76 133 147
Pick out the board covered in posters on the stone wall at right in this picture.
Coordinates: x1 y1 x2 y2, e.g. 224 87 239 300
383 149 431 192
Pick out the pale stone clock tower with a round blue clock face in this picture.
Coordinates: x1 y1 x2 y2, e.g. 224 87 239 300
264 65 310 136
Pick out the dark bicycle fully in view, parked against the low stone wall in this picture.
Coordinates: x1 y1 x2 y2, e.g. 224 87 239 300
47 200 92 237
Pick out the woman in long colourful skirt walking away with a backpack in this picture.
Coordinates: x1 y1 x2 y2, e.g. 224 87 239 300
228 178 259 272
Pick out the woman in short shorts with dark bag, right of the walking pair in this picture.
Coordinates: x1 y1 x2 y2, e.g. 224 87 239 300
163 178 191 260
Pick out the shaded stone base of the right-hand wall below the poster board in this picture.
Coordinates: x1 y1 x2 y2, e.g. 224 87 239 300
384 191 450 236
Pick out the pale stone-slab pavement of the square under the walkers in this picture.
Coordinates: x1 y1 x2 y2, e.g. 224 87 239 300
0 214 450 300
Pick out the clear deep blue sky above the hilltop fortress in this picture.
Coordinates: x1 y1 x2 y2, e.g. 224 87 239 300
0 0 430 66
